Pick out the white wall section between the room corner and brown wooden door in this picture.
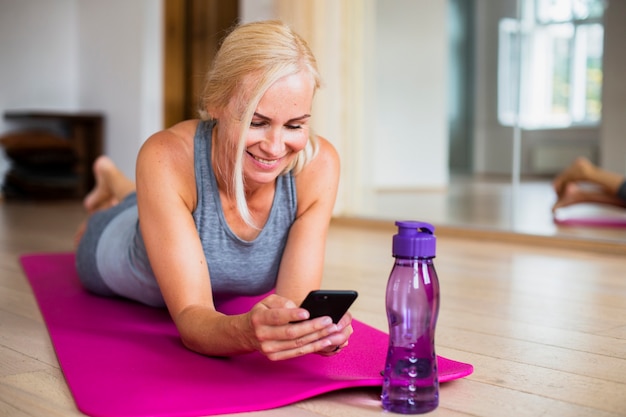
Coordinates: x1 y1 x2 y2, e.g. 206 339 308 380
78 0 163 178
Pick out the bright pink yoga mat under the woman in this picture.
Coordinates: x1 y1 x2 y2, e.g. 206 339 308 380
20 253 473 417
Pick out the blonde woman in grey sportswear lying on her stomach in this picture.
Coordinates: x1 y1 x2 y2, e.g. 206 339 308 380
76 22 352 360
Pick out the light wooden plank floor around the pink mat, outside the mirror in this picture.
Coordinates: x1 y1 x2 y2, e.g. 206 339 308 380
0 202 626 417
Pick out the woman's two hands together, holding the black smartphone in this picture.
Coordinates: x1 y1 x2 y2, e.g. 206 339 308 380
248 294 353 361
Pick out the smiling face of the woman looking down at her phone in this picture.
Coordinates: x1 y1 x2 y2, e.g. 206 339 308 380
227 72 314 185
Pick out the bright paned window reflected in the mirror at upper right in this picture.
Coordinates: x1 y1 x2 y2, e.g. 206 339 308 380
498 0 605 129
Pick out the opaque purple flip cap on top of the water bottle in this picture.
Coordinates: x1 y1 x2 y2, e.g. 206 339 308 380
392 221 437 258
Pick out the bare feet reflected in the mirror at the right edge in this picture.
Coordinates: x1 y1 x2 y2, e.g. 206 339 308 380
552 157 626 211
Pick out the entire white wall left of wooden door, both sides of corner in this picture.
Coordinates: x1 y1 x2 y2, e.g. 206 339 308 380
0 0 162 184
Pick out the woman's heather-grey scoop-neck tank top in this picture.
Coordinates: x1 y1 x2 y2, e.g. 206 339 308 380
193 121 297 299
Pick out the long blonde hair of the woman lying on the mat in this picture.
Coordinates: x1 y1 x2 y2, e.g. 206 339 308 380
200 20 321 227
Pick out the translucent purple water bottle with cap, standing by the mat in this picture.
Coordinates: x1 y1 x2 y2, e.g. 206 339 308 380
381 221 439 414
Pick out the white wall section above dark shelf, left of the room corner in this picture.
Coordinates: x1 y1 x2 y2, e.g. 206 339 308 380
0 0 78 110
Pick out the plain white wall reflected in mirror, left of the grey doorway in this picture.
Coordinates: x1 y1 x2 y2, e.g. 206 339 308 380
366 0 448 188
